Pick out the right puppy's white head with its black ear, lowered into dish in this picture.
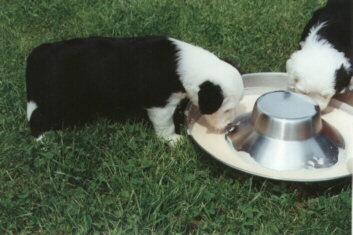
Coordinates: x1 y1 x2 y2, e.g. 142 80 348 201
286 40 352 110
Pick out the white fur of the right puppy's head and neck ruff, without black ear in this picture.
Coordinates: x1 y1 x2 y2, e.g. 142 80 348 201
286 22 350 110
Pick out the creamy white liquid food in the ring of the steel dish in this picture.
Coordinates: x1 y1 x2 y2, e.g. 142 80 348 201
191 91 353 181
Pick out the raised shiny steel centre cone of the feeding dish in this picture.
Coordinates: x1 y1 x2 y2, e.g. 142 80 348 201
227 91 344 170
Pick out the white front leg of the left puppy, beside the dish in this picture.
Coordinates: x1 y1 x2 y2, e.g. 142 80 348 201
147 105 182 147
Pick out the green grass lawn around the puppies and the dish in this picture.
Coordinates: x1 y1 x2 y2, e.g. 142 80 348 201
0 0 352 234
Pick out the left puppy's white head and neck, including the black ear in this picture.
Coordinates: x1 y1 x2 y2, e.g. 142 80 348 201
172 39 244 130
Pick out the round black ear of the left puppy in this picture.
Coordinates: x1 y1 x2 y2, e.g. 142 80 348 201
198 81 223 114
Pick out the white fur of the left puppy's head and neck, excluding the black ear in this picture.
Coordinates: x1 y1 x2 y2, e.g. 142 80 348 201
170 38 244 129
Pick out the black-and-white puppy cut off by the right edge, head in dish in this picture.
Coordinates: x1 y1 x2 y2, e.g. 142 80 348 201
287 0 353 110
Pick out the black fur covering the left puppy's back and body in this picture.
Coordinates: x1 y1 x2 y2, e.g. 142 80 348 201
26 36 185 137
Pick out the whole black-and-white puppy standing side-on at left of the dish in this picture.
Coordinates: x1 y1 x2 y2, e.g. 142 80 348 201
26 36 244 145
